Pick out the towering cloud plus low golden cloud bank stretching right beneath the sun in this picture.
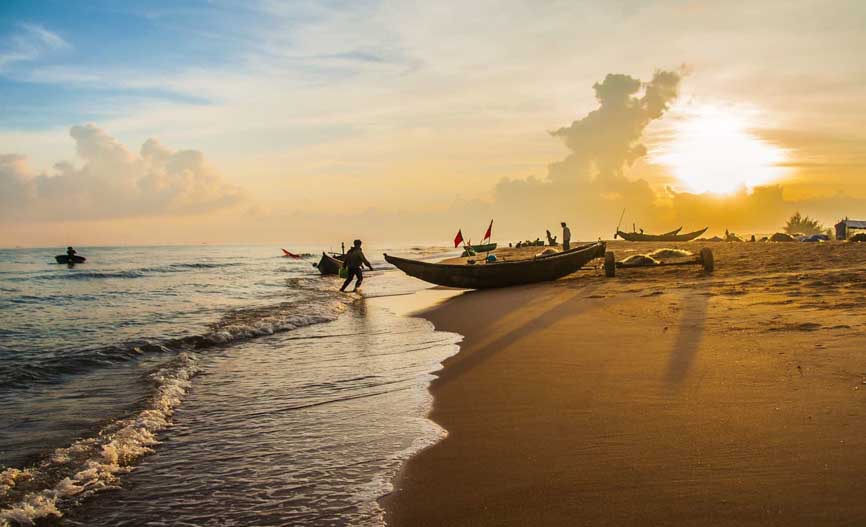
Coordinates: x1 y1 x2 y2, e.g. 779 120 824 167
486 71 866 238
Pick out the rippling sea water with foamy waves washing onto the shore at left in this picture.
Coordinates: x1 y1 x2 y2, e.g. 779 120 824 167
0 246 459 526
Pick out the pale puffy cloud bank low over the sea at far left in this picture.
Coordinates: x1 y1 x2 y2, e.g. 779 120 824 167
0 124 247 221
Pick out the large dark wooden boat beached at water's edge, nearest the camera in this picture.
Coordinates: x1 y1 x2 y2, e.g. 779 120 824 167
385 242 606 289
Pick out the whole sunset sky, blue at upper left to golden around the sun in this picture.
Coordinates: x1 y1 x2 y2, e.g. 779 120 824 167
0 0 866 247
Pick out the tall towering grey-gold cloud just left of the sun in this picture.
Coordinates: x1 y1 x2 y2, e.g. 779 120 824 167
495 71 680 232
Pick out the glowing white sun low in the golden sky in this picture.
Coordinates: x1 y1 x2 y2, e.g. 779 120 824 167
650 105 787 194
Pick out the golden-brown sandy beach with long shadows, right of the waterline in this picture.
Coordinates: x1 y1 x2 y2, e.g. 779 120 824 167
382 242 866 526
